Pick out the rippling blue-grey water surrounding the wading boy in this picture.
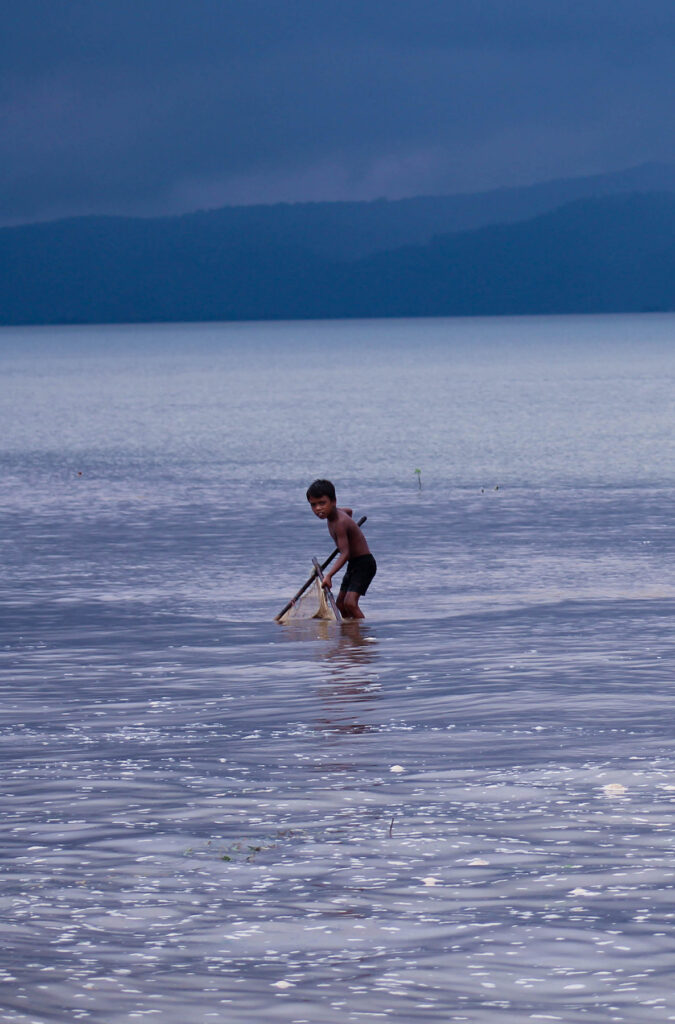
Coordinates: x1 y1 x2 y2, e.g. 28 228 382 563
0 315 675 1024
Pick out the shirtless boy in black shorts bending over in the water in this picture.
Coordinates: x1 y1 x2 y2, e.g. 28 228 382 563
307 480 377 618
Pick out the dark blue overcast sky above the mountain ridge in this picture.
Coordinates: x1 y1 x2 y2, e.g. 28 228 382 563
0 0 675 223
